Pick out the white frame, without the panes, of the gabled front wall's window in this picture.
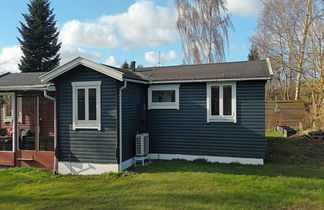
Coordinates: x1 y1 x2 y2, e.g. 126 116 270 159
72 81 101 130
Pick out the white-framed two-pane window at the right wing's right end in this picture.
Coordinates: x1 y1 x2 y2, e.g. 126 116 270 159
207 83 236 123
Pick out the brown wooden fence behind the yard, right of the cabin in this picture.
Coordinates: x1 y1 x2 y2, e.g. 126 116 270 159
265 101 311 130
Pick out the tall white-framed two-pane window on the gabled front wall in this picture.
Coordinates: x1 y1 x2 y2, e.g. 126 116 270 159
72 81 101 130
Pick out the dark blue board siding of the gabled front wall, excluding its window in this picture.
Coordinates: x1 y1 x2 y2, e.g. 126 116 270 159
56 66 118 164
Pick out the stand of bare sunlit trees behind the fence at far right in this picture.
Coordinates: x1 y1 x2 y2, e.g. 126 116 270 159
251 0 324 126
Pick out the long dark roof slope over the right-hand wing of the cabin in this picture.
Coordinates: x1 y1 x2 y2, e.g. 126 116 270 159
136 60 272 83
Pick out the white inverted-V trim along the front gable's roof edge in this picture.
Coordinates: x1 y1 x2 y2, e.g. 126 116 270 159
39 57 123 82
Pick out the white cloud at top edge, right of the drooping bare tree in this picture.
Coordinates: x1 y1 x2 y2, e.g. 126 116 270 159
227 0 262 17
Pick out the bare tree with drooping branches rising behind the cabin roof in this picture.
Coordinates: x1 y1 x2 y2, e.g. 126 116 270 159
175 0 233 64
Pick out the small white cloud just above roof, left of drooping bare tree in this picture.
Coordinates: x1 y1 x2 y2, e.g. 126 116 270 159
144 50 178 65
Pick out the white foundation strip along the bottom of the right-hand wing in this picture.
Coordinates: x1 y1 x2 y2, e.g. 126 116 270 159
150 153 263 165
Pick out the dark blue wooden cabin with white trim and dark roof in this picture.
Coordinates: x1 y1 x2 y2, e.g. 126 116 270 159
36 58 271 174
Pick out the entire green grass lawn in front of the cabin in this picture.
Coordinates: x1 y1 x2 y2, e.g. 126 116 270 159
0 139 324 209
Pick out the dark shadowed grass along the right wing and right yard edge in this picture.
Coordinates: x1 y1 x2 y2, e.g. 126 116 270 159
132 136 324 179
